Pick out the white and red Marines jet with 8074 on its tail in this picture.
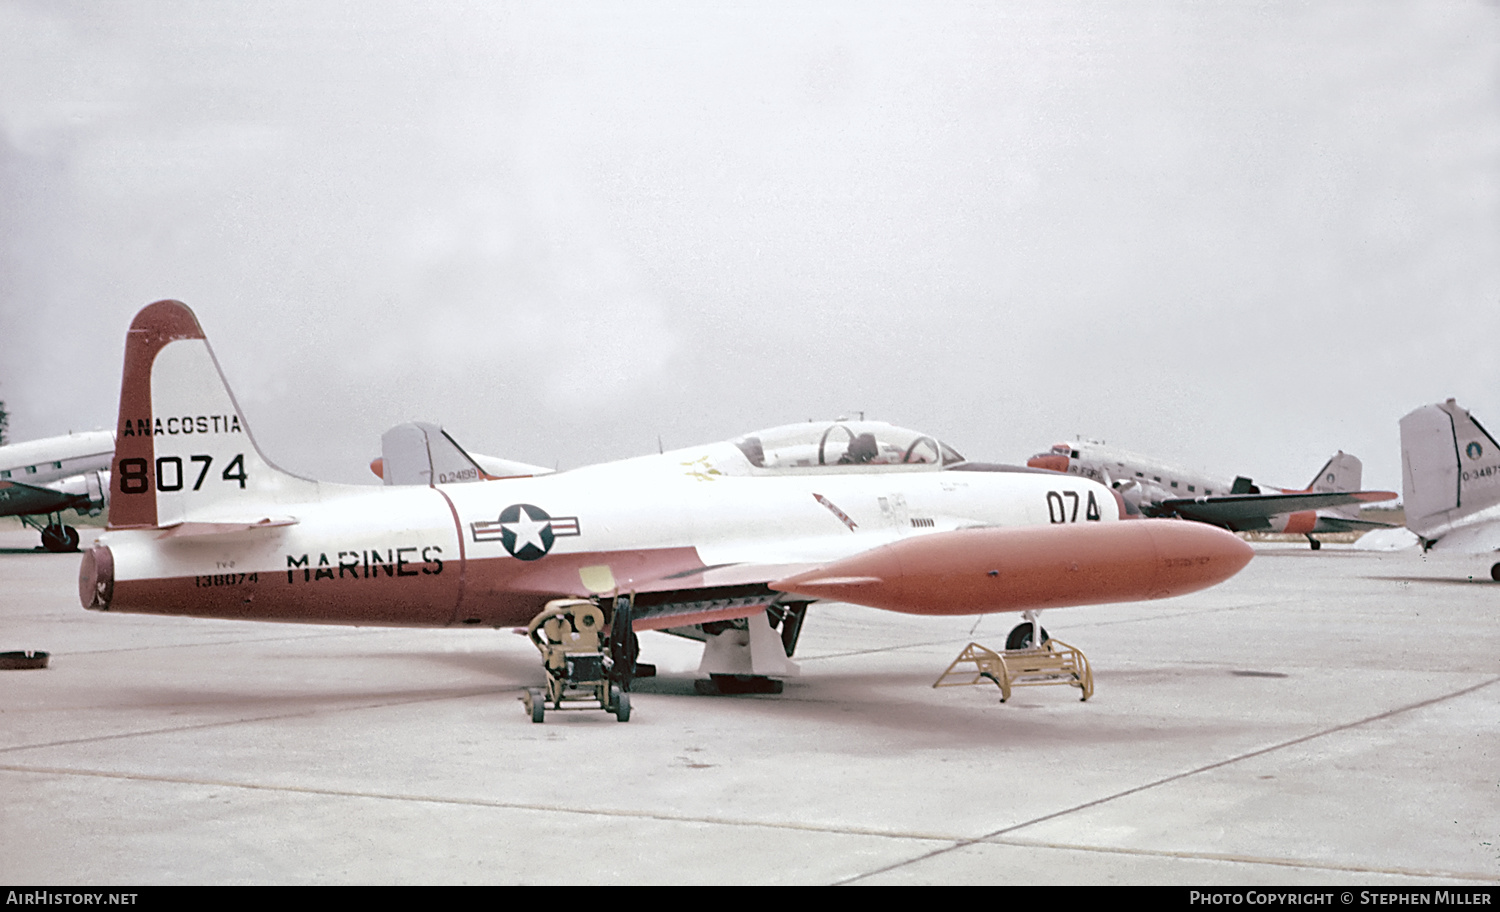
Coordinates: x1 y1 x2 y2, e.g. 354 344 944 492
80 302 1251 696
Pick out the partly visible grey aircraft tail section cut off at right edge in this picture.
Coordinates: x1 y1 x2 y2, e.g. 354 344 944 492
1401 399 1500 582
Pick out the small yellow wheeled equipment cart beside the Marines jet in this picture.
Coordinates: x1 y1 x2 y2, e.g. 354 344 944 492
521 596 639 722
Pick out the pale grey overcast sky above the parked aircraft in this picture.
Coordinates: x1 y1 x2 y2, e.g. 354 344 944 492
0 0 1500 489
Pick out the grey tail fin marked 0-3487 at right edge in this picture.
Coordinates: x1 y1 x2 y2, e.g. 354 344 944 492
1401 399 1500 539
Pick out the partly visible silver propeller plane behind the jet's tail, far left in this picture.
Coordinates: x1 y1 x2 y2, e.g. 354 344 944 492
0 431 114 552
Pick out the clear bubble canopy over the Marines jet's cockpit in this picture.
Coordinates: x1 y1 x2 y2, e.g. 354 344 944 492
734 420 963 471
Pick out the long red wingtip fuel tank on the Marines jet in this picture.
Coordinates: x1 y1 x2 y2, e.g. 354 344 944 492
771 519 1254 615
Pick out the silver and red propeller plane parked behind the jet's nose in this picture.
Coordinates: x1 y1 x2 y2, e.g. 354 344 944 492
1026 441 1397 551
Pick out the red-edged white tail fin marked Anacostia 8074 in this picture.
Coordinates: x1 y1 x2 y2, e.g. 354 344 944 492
110 300 318 530
